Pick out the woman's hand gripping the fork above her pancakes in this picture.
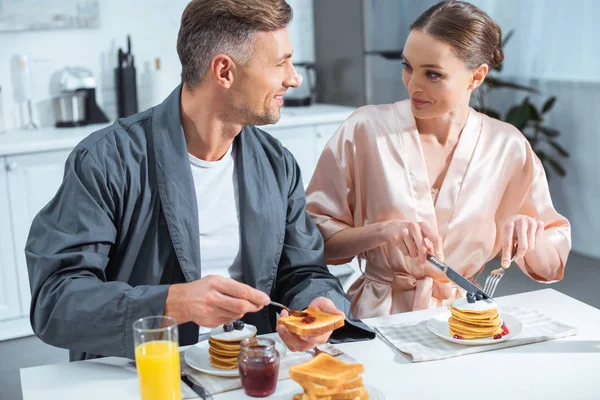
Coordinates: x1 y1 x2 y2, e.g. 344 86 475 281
502 214 545 268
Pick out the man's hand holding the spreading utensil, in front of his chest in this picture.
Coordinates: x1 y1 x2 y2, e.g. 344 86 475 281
165 275 270 328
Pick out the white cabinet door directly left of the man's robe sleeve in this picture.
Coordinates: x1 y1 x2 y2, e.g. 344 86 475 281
6 150 70 316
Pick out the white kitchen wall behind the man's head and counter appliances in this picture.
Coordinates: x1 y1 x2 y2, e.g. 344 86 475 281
0 0 314 130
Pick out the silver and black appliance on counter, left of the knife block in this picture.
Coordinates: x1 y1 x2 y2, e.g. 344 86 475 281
52 67 108 128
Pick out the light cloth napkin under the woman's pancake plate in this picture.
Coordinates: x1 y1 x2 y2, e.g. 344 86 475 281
375 307 577 362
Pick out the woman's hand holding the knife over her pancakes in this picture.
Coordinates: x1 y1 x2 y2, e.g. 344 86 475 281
380 219 444 262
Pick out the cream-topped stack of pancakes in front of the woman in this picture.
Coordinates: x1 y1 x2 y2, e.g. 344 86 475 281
448 298 502 340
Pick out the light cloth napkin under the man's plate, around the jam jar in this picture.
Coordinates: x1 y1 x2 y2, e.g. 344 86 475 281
181 333 313 395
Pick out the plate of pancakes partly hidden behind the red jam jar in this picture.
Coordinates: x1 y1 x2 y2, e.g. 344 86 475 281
185 321 287 377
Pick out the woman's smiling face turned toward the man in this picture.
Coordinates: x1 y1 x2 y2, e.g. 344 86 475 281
402 30 488 119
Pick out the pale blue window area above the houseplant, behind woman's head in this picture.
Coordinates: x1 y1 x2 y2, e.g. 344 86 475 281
471 0 600 82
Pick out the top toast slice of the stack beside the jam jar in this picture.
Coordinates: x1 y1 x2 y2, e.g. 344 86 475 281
289 353 365 387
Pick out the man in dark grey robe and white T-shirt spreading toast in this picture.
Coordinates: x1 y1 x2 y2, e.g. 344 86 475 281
26 0 373 360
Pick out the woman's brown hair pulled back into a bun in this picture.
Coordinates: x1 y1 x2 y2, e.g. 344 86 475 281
410 0 504 69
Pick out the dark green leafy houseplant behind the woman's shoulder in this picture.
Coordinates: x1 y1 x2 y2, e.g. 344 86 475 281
474 31 569 178
